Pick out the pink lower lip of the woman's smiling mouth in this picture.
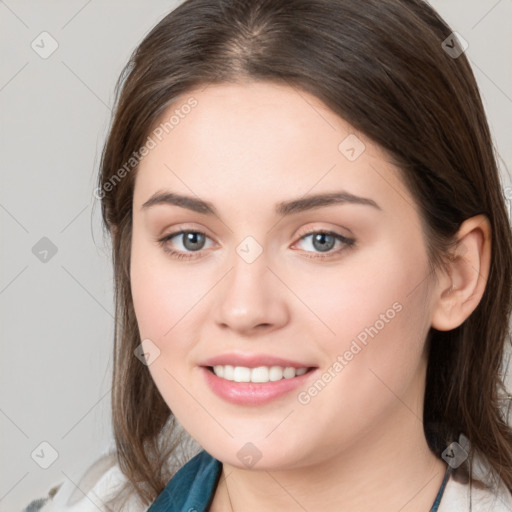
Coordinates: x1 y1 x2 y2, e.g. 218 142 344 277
201 366 317 405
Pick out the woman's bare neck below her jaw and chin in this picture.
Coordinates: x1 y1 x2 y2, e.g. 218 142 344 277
210 405 446 512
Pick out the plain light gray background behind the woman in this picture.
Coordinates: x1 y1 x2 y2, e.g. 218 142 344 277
0 0 512 512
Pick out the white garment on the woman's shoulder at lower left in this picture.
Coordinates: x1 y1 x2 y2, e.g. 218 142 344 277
22 453 147 512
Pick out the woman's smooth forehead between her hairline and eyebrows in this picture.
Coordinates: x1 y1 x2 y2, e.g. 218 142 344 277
134 82 414 216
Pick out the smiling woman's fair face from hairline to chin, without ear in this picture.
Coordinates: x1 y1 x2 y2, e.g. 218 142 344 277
131 82 434 469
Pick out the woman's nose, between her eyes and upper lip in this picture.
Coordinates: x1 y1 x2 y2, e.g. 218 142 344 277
215 247 289 336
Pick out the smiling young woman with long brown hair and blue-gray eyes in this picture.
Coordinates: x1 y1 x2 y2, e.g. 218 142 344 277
24 0 512 512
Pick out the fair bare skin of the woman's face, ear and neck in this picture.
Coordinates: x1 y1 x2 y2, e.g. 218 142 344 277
131 82 490 512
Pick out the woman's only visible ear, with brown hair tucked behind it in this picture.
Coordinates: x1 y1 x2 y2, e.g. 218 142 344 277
432 215 491 331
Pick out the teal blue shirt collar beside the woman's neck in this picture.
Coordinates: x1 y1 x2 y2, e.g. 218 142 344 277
147 450 451 512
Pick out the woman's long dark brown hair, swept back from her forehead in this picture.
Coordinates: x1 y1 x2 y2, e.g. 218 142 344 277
98 0 512 503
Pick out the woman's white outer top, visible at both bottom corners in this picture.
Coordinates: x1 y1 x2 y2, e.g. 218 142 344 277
22 454 512 512
